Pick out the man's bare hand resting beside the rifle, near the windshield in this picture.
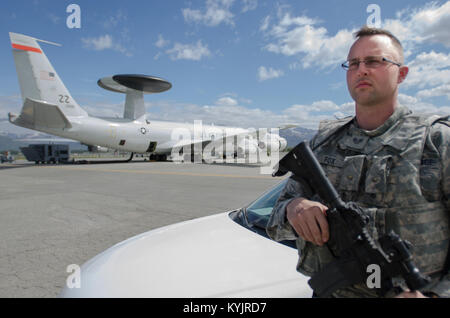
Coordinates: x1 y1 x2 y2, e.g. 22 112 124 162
286 198 329 246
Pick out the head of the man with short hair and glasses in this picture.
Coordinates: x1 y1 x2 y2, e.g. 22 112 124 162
343 26 408 106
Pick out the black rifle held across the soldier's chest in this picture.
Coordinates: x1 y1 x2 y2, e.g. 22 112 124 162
273 142 430 297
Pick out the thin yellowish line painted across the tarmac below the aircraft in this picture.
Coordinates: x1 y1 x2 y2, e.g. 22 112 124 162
41 166 282 180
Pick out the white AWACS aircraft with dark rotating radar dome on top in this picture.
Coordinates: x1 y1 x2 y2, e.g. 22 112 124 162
9 33 292 160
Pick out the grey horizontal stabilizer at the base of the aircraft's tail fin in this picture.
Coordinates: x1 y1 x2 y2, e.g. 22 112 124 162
9 98 72 129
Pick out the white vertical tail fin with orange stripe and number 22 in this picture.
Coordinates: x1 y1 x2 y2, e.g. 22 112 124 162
9 32 88 117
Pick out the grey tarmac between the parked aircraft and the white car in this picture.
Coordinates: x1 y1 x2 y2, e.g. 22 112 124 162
0 160 283 298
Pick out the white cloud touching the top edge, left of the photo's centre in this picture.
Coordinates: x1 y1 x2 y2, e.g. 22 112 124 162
182 0 234 27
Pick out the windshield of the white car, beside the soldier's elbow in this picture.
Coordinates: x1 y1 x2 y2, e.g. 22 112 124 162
245 178 288 228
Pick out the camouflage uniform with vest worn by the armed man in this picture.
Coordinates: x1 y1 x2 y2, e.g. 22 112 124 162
267 106 450 297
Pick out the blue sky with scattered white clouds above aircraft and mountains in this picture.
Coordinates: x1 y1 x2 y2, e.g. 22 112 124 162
0 0 450 131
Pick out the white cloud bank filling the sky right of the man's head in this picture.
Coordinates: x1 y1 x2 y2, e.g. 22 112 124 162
383 1 450 99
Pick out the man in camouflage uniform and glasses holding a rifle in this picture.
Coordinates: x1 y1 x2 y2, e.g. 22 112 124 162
267 27 450 297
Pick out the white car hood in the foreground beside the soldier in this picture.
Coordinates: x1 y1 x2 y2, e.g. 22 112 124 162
61 212 312 298
